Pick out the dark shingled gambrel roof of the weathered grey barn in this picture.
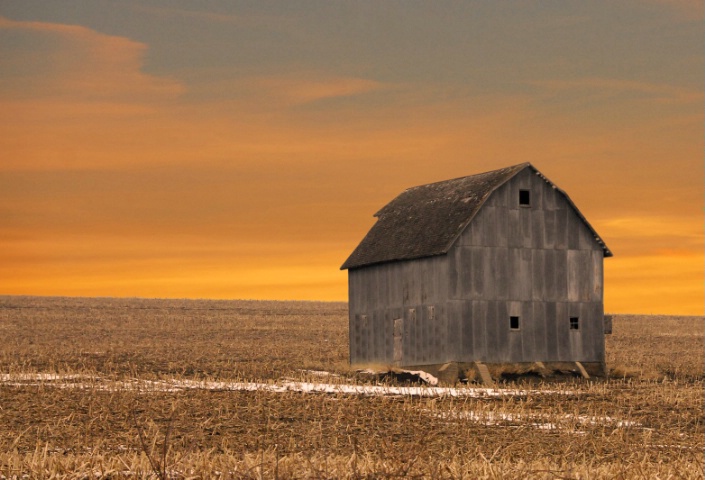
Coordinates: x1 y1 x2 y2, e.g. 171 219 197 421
340 163 612 270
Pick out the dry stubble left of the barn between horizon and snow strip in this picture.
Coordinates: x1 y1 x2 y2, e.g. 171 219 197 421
0 297 348 379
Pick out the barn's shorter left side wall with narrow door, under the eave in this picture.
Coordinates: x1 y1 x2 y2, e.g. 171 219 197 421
348 256 458 365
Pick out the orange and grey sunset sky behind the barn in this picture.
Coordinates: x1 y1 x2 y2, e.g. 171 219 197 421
0 0 705 315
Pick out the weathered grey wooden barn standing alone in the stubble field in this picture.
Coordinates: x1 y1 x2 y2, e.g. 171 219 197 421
341 163 612 376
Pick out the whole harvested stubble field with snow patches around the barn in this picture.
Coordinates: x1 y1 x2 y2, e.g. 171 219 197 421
0 297 705 479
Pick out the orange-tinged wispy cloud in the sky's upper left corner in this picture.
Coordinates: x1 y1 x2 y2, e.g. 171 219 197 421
0 17 184 102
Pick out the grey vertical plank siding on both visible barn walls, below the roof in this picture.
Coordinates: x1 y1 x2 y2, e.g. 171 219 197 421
348 169 605 366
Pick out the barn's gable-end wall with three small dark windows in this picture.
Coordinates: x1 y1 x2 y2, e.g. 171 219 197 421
448 169 604 362
